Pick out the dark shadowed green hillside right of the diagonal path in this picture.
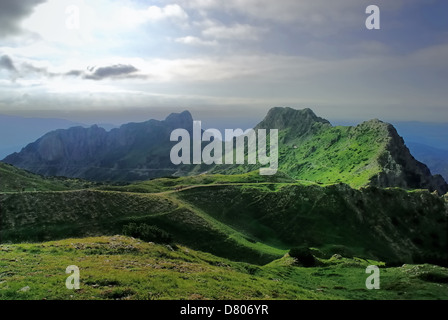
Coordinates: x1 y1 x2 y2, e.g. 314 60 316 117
175 184 448 264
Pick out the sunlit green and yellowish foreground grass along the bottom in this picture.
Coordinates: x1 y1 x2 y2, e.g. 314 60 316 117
0 236 448 300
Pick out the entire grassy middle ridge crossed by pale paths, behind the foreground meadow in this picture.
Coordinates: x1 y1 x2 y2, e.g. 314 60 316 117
0 173 448 263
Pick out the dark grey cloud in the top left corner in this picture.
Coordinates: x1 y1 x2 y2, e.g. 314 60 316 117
0 0 46 37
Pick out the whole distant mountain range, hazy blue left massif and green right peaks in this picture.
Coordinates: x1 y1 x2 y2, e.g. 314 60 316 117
4 108 448 193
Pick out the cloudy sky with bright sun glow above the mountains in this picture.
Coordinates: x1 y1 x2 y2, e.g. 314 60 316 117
0 0 448 126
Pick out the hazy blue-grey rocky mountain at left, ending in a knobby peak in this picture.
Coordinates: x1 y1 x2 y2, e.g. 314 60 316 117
4 111 193 181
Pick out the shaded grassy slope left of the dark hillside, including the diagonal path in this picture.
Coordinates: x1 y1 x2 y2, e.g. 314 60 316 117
0 190 285 264
